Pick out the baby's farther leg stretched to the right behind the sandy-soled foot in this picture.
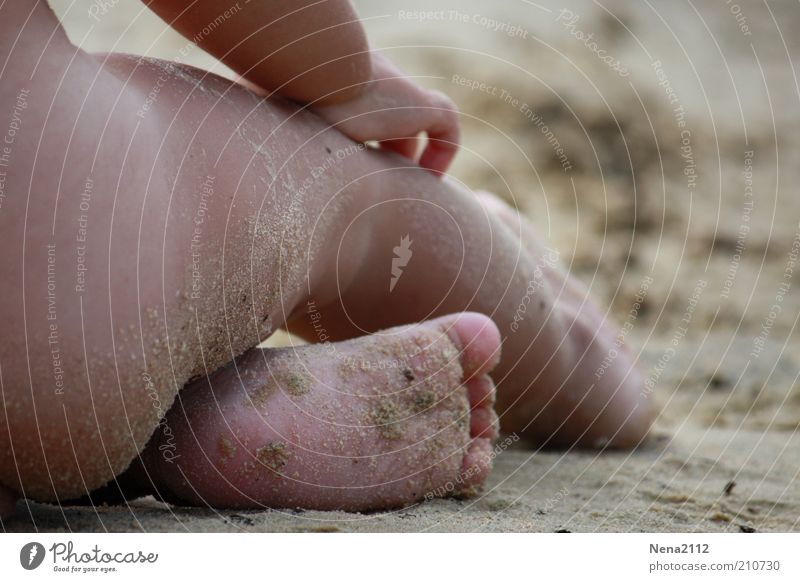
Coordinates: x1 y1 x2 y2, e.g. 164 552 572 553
290 176 652 446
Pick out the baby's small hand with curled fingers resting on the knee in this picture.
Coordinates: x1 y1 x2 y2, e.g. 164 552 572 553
314 53 460 174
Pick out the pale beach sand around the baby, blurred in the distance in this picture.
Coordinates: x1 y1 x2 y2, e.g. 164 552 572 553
6 0 800 532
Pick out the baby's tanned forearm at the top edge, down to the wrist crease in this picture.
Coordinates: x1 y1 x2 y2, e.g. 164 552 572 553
146 0 371 103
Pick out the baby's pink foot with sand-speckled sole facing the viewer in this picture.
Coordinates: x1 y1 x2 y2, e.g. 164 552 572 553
136 313 500 511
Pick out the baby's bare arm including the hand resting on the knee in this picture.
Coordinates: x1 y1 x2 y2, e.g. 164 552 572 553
145 0 459 172
